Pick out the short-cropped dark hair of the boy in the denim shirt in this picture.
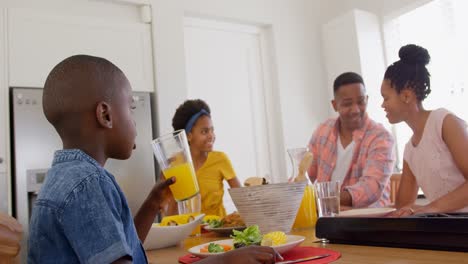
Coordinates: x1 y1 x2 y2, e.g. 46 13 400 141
42 55 126 134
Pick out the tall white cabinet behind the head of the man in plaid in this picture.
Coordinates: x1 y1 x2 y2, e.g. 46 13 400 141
323 9 389 125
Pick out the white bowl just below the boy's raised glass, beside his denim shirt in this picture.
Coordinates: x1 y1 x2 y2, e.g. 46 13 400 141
143 214 205 250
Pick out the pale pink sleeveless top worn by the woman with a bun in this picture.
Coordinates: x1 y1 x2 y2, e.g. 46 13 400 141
403 108 468 212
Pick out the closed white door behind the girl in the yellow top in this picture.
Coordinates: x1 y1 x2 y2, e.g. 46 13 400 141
184 18 271 213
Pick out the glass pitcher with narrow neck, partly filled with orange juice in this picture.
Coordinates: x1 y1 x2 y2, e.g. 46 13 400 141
288 148 317 228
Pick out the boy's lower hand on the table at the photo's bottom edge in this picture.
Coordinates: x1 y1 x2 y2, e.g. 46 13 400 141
207 246 283 264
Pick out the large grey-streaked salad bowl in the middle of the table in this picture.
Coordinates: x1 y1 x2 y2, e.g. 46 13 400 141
229 182 307 234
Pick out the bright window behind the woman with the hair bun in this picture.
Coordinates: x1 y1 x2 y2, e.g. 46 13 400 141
384 0 468 169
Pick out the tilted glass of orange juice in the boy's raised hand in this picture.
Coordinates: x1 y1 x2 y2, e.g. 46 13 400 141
152 129 200 202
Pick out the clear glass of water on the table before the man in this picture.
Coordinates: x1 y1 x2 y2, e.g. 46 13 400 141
315 181 340 217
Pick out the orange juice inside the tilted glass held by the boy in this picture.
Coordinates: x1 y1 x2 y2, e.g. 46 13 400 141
163 162 200 201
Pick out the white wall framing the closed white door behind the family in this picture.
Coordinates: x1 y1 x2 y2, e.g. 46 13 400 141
152 0 328 179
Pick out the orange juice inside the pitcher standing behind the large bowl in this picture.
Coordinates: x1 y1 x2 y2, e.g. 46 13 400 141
293 184 317 228
